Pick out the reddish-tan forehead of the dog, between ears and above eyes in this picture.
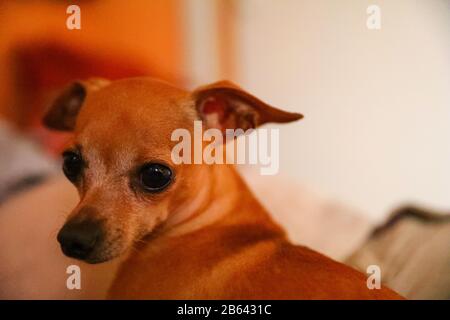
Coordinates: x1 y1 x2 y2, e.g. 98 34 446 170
75 78 196 164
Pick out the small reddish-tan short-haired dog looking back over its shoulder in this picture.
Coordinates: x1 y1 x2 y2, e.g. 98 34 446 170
43 77 401 299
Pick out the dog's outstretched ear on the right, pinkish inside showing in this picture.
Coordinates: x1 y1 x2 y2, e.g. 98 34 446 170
193 81 303 133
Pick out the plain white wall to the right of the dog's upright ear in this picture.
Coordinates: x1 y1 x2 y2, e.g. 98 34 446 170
235 0 450 218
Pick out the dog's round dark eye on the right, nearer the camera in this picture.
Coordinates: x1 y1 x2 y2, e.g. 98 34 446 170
139 163 172 192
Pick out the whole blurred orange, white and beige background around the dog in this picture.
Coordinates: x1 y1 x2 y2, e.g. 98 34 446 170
0 0 450 299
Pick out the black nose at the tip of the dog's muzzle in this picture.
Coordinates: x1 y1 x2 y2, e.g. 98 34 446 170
57 219 102 260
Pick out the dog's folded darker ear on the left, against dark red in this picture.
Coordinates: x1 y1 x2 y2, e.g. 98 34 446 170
42 78 110 131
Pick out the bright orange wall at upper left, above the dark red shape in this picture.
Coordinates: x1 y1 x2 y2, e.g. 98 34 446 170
0 0 184 123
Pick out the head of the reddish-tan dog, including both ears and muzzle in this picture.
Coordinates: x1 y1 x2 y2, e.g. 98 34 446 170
44 78 301 263
